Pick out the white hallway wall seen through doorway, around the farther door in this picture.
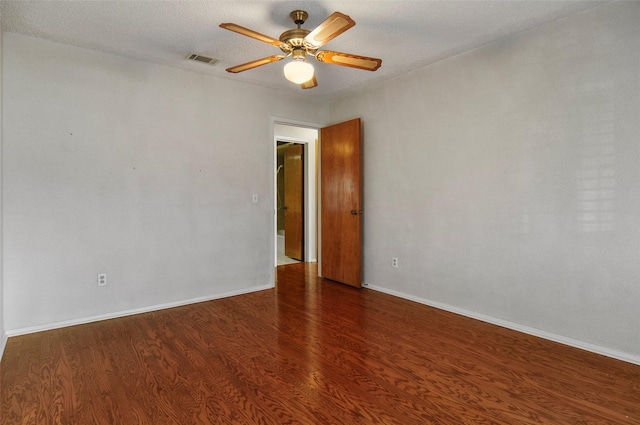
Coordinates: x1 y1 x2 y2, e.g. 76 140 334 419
274 123 318 262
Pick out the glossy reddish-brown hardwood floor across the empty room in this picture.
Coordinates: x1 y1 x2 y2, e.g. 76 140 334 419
0 263 640 425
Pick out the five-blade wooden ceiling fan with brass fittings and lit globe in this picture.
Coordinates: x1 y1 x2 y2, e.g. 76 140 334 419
220 10 382 89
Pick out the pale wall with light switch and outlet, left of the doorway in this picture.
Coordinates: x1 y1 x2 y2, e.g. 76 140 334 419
3 33 323 335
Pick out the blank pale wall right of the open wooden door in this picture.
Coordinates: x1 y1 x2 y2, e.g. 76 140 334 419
330 2 640 363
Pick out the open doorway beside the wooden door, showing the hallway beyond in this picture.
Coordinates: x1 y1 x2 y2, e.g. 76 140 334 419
273 121 319 266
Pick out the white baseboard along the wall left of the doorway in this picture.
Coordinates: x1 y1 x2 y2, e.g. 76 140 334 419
2 285 273 338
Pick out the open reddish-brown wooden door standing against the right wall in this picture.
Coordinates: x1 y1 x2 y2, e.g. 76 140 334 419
320 118 362 288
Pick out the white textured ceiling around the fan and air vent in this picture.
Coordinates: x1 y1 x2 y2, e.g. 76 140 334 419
0 0 606 98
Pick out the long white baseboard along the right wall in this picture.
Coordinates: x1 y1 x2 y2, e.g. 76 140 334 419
366 285 640 365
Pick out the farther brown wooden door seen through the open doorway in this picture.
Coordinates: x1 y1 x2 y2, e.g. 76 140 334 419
284 144 304 261
